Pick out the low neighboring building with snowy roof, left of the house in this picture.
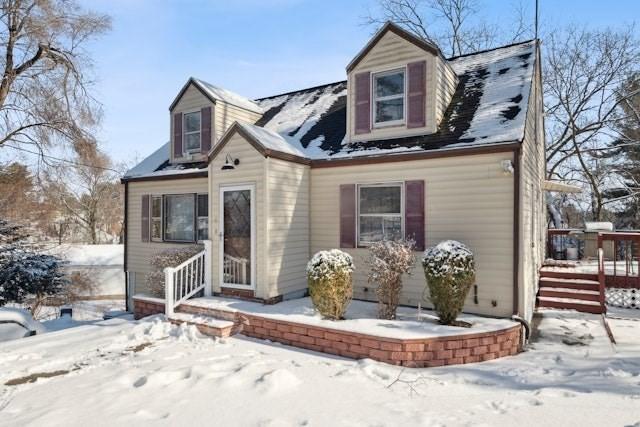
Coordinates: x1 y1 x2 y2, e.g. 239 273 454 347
50 244 126 300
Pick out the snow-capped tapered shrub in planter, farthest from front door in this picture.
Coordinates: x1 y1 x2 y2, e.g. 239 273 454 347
422 240 476 325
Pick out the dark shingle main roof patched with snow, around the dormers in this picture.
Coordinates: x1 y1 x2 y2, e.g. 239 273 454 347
125 40 536 179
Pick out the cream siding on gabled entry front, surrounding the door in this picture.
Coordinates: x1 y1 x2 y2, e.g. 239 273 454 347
209 133 272 298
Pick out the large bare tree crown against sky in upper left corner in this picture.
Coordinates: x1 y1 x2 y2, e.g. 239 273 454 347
0 0 110 155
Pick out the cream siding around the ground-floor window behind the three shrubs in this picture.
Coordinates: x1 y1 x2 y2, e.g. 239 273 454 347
311 151 514 316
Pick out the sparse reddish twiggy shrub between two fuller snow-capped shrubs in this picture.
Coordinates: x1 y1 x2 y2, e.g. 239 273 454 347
368 240 416 320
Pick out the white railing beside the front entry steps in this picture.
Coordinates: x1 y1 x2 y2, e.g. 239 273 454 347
164 240 211 316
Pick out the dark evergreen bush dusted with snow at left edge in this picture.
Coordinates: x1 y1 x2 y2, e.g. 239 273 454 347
0 220 68 317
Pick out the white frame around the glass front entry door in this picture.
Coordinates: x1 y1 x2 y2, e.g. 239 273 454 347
218 184 256 291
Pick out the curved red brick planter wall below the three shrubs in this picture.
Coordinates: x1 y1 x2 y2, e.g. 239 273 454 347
238 313 521 367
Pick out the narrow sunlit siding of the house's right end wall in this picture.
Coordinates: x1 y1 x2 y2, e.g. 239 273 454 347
518 51 546 320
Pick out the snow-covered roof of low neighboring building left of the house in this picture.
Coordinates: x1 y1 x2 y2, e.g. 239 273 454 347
49 244 124 266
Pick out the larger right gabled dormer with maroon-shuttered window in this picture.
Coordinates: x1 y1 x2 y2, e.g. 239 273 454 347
347 22 458 141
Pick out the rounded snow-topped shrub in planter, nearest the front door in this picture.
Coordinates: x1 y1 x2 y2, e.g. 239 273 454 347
307 249 354 320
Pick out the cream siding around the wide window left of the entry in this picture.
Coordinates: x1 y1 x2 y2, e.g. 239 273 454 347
127 178 208 294
